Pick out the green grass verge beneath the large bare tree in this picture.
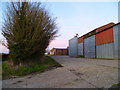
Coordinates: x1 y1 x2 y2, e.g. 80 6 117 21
2 56 61 79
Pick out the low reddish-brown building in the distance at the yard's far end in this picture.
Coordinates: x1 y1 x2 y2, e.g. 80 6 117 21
49 48 68 55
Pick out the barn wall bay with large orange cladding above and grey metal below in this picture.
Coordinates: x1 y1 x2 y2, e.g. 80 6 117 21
96 27 114 58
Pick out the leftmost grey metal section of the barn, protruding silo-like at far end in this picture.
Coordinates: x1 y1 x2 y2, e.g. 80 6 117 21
69 37 78 57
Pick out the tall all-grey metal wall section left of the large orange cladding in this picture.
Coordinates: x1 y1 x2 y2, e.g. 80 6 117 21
84 35 95 58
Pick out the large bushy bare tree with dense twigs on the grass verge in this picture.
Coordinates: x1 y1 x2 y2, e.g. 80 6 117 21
2 2 58 65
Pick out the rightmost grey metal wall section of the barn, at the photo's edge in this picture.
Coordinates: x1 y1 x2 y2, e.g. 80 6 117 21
113 24 120 59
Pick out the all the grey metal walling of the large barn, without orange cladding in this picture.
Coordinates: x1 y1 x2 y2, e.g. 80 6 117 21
69 23 120 59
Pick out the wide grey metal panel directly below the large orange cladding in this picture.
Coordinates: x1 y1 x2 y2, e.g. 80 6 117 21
96 43 114 58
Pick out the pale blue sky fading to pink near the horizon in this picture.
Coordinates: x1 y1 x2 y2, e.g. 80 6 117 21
0 2 118 52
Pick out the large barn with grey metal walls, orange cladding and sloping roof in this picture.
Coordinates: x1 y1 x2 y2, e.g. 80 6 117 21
69 23 120 59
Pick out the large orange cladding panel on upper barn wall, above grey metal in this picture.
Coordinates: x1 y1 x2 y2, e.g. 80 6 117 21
96 28 114 45
